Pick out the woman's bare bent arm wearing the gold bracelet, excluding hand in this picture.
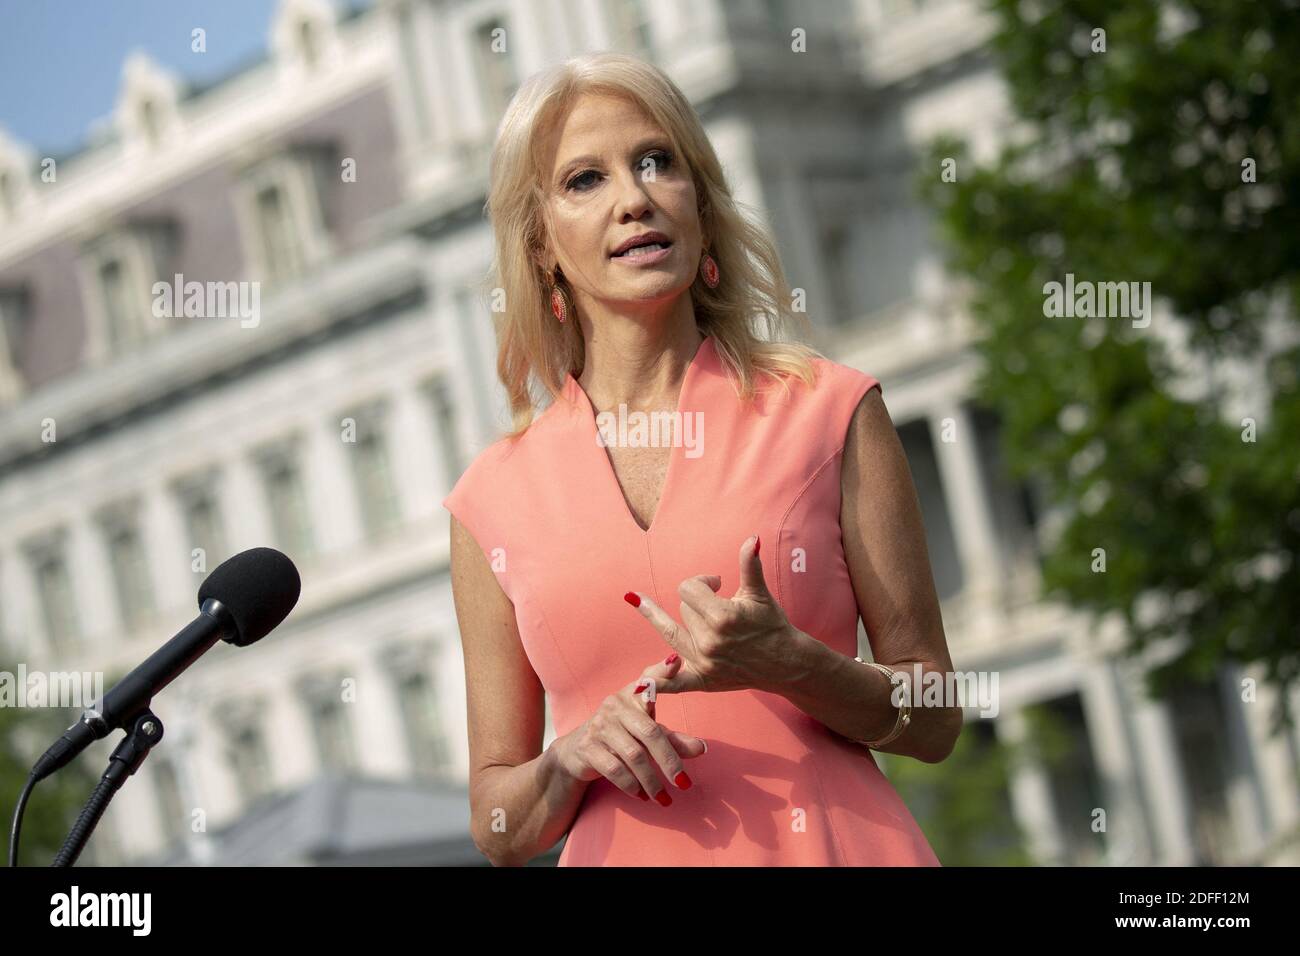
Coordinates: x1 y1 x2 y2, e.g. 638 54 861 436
780 389 962 763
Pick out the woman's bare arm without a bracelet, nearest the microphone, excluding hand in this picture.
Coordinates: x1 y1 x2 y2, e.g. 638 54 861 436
451 516 588 866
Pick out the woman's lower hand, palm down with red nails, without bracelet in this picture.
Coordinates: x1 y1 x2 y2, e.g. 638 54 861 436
556 657 707 806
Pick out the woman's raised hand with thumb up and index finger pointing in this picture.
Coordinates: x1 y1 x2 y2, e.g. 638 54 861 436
625 536 806 693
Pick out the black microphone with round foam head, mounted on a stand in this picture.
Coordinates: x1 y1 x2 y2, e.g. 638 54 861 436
31 548 302 780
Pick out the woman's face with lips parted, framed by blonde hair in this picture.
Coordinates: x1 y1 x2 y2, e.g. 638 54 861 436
547 94 703 307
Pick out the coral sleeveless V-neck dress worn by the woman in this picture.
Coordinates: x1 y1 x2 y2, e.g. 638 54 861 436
443 336 939 866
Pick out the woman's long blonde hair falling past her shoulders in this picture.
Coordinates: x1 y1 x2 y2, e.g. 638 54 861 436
484 52 822 438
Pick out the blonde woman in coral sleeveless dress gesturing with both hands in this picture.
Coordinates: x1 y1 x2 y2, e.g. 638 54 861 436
443 53 961 866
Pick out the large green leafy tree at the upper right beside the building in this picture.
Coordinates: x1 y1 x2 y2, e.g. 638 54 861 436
920 0 1300 730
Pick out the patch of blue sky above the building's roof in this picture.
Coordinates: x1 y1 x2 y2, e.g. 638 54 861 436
0 0 372 156
